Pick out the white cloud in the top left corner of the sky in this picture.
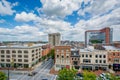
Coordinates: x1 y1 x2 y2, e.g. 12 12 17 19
0 0 16 16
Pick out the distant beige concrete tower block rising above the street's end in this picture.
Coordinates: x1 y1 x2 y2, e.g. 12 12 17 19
48 33 61 46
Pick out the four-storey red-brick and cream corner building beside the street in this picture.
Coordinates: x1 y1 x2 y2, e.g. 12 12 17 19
55 46 71 71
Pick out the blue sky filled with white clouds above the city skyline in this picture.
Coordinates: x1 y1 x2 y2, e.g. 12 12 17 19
0 0 120 41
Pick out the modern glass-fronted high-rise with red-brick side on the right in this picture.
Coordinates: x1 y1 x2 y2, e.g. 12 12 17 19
85 27 113 47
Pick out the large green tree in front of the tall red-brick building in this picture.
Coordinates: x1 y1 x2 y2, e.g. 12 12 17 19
57 68 77 80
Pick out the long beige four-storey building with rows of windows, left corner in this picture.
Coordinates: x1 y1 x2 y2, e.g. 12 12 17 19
0 44 42 68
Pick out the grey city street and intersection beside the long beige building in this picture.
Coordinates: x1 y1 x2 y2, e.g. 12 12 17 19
10 59 56 80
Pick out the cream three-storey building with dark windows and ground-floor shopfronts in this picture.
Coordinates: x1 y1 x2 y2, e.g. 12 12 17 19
80 49 108 70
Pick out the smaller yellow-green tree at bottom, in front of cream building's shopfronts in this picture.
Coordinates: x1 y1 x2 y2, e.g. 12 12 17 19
83 71 96 80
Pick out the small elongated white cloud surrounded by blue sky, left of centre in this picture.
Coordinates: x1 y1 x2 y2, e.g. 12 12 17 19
15 12 37 22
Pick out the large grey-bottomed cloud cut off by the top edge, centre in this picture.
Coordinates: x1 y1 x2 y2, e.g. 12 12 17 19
39 0 82 18
